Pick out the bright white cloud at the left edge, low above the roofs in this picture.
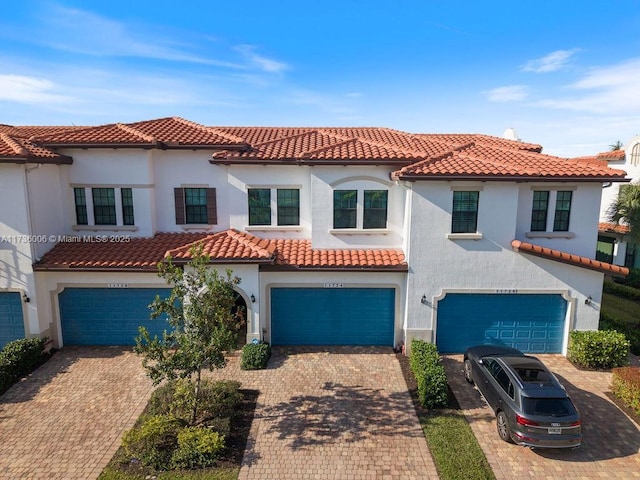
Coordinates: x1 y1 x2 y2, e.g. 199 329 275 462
0 74 71 104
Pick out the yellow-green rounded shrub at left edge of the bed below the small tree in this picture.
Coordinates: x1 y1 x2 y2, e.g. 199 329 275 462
122 415 184 470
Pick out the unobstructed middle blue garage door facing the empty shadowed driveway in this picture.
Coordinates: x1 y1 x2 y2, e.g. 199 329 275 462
271 288 395 346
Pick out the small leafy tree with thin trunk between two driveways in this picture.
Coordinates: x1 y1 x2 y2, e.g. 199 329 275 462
134 244 240 425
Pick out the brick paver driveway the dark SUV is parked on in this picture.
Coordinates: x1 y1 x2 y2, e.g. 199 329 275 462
444 355 640 480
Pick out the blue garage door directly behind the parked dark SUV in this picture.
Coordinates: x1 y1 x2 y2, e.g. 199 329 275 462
436 293 567 353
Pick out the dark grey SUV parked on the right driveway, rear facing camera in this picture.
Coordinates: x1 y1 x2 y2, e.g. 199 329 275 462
464 345 582 448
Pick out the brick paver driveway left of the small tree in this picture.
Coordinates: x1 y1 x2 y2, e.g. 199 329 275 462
0 347 152 480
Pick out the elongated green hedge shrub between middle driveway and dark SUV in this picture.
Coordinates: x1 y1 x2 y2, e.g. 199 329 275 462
410 339 448 408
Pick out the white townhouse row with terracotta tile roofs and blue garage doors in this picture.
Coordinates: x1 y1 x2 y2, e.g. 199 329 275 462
0 118 627 353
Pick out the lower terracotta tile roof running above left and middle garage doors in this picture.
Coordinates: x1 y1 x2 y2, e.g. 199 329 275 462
33 229 407 271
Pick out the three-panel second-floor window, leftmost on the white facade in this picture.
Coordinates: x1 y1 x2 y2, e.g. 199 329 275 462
73 187 135 225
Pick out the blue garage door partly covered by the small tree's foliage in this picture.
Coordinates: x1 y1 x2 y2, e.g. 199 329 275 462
58 288 171 345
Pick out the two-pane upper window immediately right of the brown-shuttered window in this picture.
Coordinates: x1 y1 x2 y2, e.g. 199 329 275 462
247 188 300 226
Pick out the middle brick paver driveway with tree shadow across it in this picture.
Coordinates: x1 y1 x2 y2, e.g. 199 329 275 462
208 347 438 480
